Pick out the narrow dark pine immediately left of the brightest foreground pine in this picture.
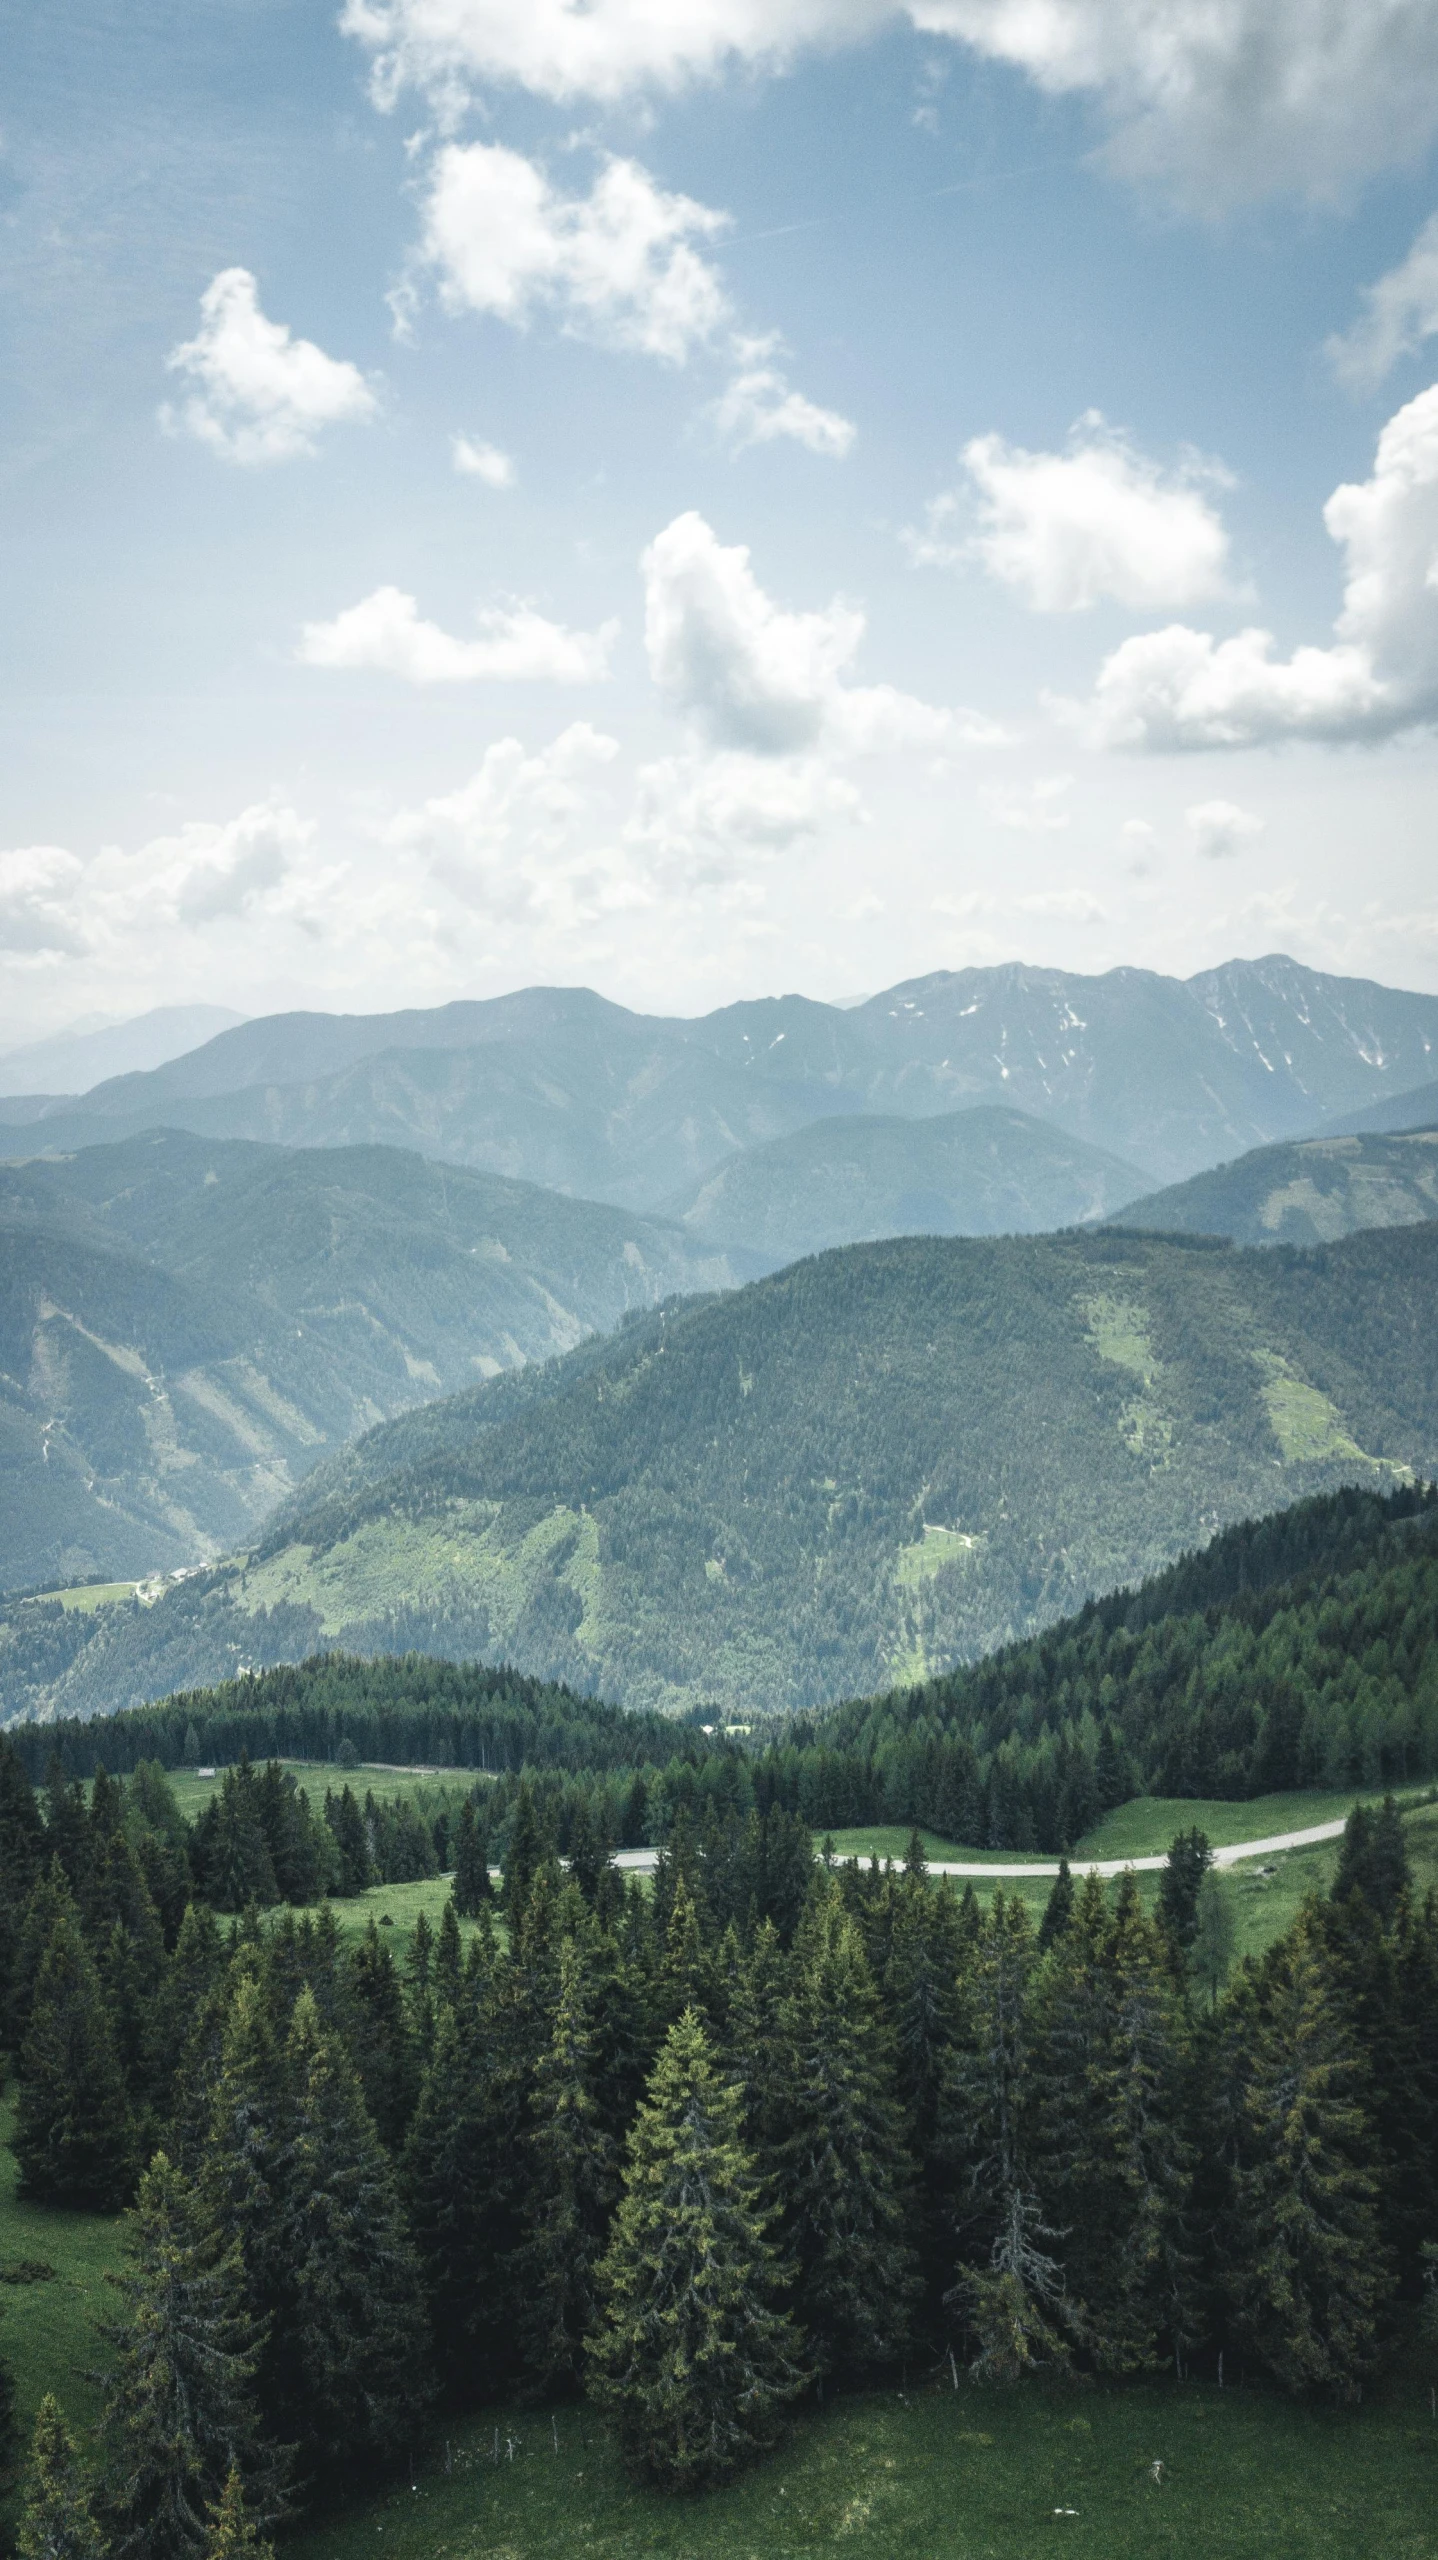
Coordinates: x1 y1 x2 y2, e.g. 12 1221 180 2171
517 1938 617 2391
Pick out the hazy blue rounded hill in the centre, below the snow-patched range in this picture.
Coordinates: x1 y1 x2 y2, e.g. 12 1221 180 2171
670 1103 1144 1270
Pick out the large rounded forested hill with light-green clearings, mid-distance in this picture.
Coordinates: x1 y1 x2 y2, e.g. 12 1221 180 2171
13 1226 1438 1715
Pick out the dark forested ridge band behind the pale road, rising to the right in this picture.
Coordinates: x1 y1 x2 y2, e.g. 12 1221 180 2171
13 1485 1438 1873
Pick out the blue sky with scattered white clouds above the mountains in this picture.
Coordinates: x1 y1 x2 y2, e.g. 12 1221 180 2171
0 0 1438 1044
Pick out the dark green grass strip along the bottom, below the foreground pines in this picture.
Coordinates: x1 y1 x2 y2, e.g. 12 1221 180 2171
292 2363 1438 2560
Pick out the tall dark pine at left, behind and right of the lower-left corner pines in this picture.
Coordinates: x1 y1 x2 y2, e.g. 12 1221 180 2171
284 1992 425 2473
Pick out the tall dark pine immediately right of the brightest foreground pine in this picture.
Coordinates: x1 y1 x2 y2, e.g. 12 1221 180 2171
773 1887 919 2371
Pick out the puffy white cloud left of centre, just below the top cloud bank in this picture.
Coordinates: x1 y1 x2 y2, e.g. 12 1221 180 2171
420 143 729 364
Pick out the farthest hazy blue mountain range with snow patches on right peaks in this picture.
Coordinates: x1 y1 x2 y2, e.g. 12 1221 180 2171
0 957 1438 1208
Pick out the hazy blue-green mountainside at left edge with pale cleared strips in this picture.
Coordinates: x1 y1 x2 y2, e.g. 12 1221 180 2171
0 1132 732 1590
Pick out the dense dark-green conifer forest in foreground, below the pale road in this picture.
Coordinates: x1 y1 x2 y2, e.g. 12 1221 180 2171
0 1746 1438 2560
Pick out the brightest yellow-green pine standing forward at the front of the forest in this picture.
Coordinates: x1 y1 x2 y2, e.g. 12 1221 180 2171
589 2010 806 2488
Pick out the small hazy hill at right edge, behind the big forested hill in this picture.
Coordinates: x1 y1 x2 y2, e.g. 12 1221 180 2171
1123 1129 1438 1244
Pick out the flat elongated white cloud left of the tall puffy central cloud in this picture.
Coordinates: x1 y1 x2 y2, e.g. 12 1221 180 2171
299 586 619 684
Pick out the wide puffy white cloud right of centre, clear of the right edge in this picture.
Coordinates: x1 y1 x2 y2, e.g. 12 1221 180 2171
908 412 1228 614
